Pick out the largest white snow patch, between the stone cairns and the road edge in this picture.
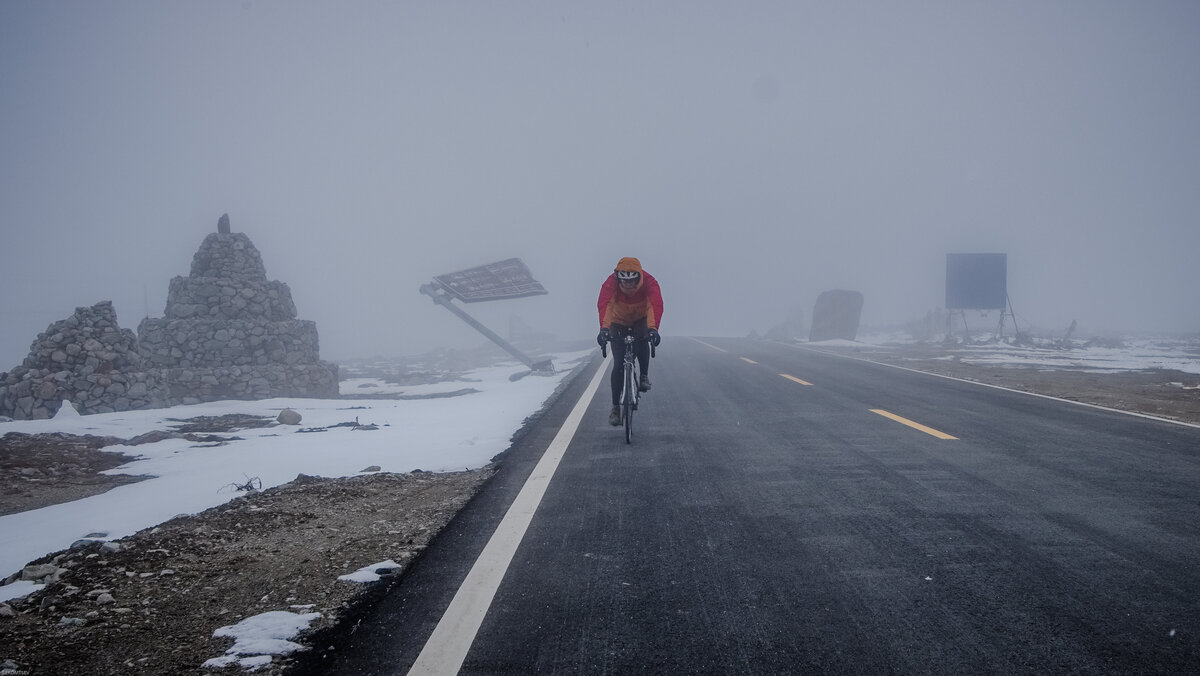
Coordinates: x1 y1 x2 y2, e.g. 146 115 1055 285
0 351 594 602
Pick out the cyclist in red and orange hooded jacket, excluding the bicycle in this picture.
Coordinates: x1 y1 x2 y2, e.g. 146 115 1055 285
596 258 662 425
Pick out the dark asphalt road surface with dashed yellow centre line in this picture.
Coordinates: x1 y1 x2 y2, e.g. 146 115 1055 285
308 337 1200 674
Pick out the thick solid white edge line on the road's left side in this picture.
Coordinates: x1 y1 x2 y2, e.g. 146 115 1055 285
408 364 607 674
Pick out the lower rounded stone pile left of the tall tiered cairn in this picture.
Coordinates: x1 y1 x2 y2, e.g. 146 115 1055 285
0 300 166 419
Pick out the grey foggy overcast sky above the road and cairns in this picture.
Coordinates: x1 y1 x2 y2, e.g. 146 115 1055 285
0 0 1200 370
